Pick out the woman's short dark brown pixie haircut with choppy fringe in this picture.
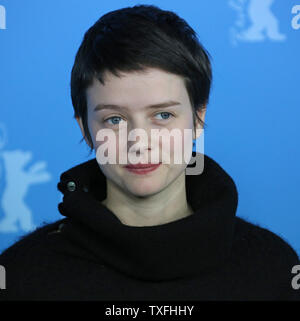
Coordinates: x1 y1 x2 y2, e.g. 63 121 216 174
71 5 212 152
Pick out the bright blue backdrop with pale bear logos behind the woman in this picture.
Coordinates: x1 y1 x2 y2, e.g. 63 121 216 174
0 0 300 254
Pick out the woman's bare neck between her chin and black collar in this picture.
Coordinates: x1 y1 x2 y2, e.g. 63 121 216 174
102 171 194 226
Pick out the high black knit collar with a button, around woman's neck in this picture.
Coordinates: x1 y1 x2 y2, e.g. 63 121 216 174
57 155 238 280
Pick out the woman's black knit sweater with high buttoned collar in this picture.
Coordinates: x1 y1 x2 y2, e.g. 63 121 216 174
0 155 300 300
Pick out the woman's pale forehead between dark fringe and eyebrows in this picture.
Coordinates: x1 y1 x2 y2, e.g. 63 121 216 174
86 68 188 109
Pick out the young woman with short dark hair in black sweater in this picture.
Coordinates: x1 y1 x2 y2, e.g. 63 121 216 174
0 5 300 300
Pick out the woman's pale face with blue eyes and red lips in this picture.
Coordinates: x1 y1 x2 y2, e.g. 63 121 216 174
77 68 204 196
